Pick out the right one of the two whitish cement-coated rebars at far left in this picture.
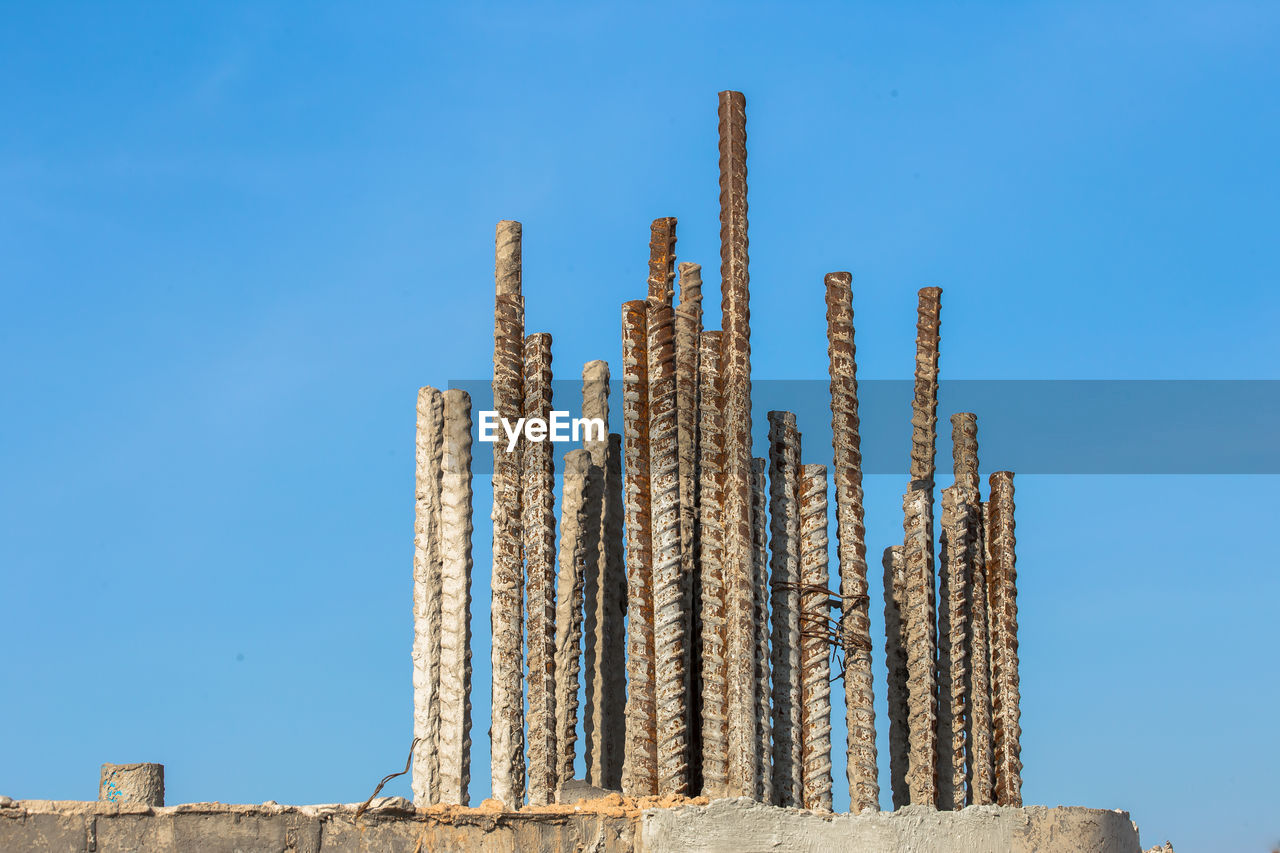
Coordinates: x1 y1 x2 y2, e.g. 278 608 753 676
438 388 472 806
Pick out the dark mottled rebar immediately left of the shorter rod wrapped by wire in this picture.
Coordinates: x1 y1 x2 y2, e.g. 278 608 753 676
768 411 804 807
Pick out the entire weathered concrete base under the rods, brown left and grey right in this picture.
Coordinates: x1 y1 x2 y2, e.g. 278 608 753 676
0 794 1142 853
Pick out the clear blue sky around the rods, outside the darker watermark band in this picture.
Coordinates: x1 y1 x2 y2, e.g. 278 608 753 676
0 1 1280 852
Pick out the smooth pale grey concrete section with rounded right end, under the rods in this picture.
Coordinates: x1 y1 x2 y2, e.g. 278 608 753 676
636 799 1142 853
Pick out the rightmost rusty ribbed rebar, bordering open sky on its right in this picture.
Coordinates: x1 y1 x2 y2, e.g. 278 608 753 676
987 471 1023 807
